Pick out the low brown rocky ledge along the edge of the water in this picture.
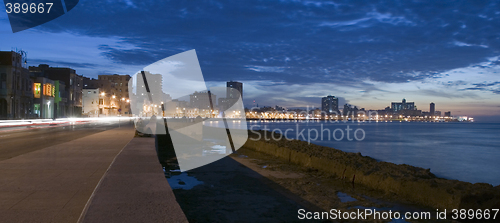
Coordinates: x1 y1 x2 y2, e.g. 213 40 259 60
244 131 500 210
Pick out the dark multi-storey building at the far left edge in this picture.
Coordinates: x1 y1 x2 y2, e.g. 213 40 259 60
0 51 33 119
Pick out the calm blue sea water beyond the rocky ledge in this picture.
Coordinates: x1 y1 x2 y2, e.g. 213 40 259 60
211 121 500 186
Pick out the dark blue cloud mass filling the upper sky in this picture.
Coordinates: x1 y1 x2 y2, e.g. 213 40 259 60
37 0 500 87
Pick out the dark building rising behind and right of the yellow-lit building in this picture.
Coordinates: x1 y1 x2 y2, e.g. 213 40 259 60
29 64 83 117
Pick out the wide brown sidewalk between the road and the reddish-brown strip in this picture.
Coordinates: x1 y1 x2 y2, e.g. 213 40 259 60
0 126 186 222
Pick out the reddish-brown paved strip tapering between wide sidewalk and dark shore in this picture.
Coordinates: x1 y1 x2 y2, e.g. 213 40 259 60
83 138 188 223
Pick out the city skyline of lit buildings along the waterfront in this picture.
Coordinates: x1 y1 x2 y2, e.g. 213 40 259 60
3 51 482 118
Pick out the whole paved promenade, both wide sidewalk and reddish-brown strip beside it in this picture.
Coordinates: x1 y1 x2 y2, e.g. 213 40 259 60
0 125 185 222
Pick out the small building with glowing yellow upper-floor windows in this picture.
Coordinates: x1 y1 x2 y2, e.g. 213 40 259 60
33 77 56 119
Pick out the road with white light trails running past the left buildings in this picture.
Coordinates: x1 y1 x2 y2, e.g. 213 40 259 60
0 121 133 161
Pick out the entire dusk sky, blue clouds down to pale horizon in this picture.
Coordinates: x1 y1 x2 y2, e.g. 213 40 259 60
0 0 500 117
